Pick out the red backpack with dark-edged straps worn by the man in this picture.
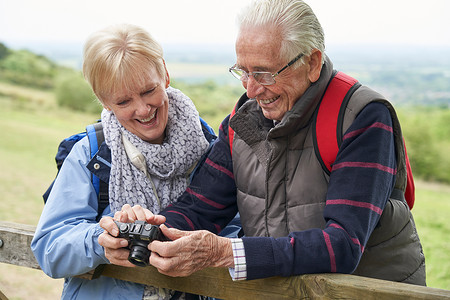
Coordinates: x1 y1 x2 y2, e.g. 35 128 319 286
228 72 415 209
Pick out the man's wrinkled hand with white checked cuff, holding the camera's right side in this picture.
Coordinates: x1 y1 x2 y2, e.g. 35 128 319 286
148 225 234 277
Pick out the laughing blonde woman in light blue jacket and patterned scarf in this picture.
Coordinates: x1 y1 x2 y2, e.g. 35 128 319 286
31 25 214 299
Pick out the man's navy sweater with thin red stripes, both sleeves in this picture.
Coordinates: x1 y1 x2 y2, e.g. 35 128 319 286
162 103 396 279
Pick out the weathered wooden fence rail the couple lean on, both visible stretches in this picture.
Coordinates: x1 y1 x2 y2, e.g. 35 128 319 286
0 221 450 300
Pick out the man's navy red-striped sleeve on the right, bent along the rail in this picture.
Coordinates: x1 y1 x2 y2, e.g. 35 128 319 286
242 103 396 279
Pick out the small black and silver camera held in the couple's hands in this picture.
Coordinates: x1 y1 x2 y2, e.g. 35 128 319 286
114 220 169 267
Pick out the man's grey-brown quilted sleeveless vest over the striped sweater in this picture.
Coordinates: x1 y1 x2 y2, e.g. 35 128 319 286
230 63 425 285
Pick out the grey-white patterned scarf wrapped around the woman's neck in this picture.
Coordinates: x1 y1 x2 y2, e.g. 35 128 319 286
102 87 209 214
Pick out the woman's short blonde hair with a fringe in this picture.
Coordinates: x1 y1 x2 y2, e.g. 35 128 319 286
83 24 166 101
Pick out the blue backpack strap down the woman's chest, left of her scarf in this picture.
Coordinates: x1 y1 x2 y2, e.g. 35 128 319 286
86 122 109 219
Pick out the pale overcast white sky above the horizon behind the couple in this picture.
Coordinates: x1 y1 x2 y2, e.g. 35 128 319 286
0 0 450 46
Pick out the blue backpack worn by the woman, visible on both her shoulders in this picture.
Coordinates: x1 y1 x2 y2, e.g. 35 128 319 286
42 118 216 221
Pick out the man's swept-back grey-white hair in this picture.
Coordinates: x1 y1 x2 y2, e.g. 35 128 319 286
237 0 325 66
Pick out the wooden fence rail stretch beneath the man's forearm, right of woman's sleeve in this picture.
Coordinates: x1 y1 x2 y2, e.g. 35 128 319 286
102 265 450 300
